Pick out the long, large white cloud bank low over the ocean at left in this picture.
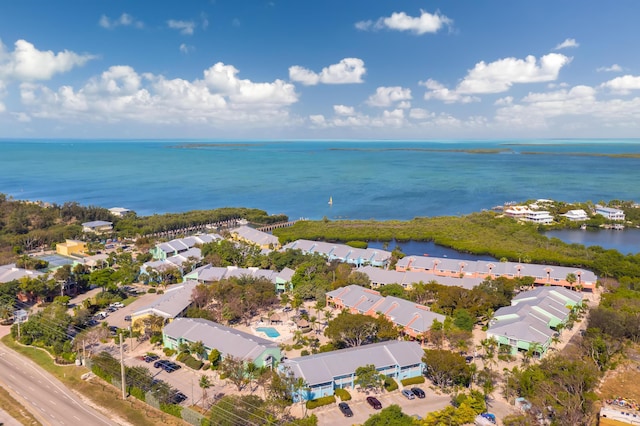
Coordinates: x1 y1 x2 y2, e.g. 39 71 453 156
20 63 298 128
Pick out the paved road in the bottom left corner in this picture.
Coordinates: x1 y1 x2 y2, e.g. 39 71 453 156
0 327 116 426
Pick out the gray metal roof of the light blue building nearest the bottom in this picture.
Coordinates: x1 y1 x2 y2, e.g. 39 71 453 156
283 340 424 386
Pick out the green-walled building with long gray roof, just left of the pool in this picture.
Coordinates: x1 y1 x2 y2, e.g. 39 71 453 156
162 318 282 368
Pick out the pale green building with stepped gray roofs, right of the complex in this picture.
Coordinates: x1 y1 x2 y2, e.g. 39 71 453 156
487 287 582 357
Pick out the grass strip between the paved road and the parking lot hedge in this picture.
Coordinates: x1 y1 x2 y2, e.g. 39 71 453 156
0 336 188 426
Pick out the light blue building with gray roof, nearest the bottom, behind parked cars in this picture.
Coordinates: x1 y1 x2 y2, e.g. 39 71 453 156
279 340 425 401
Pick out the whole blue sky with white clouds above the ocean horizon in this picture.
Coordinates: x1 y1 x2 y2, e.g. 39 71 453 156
0 0 640 140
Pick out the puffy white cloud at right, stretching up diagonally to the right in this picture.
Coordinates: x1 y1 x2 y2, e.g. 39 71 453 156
421 53 571 103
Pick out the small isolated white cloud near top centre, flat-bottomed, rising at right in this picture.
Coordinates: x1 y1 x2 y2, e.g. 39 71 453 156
289 58 367 86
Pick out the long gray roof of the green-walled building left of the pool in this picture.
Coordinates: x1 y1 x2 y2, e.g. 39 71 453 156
163 318 278 360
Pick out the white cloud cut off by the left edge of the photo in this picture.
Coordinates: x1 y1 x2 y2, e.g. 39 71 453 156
0 40 95 81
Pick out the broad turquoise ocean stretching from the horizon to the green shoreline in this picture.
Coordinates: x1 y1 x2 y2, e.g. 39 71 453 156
0 140 640 220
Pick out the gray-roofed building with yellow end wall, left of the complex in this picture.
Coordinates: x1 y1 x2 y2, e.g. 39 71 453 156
131 281 199 330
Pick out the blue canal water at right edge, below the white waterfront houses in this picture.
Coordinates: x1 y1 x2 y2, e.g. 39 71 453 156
544 228 640 254
